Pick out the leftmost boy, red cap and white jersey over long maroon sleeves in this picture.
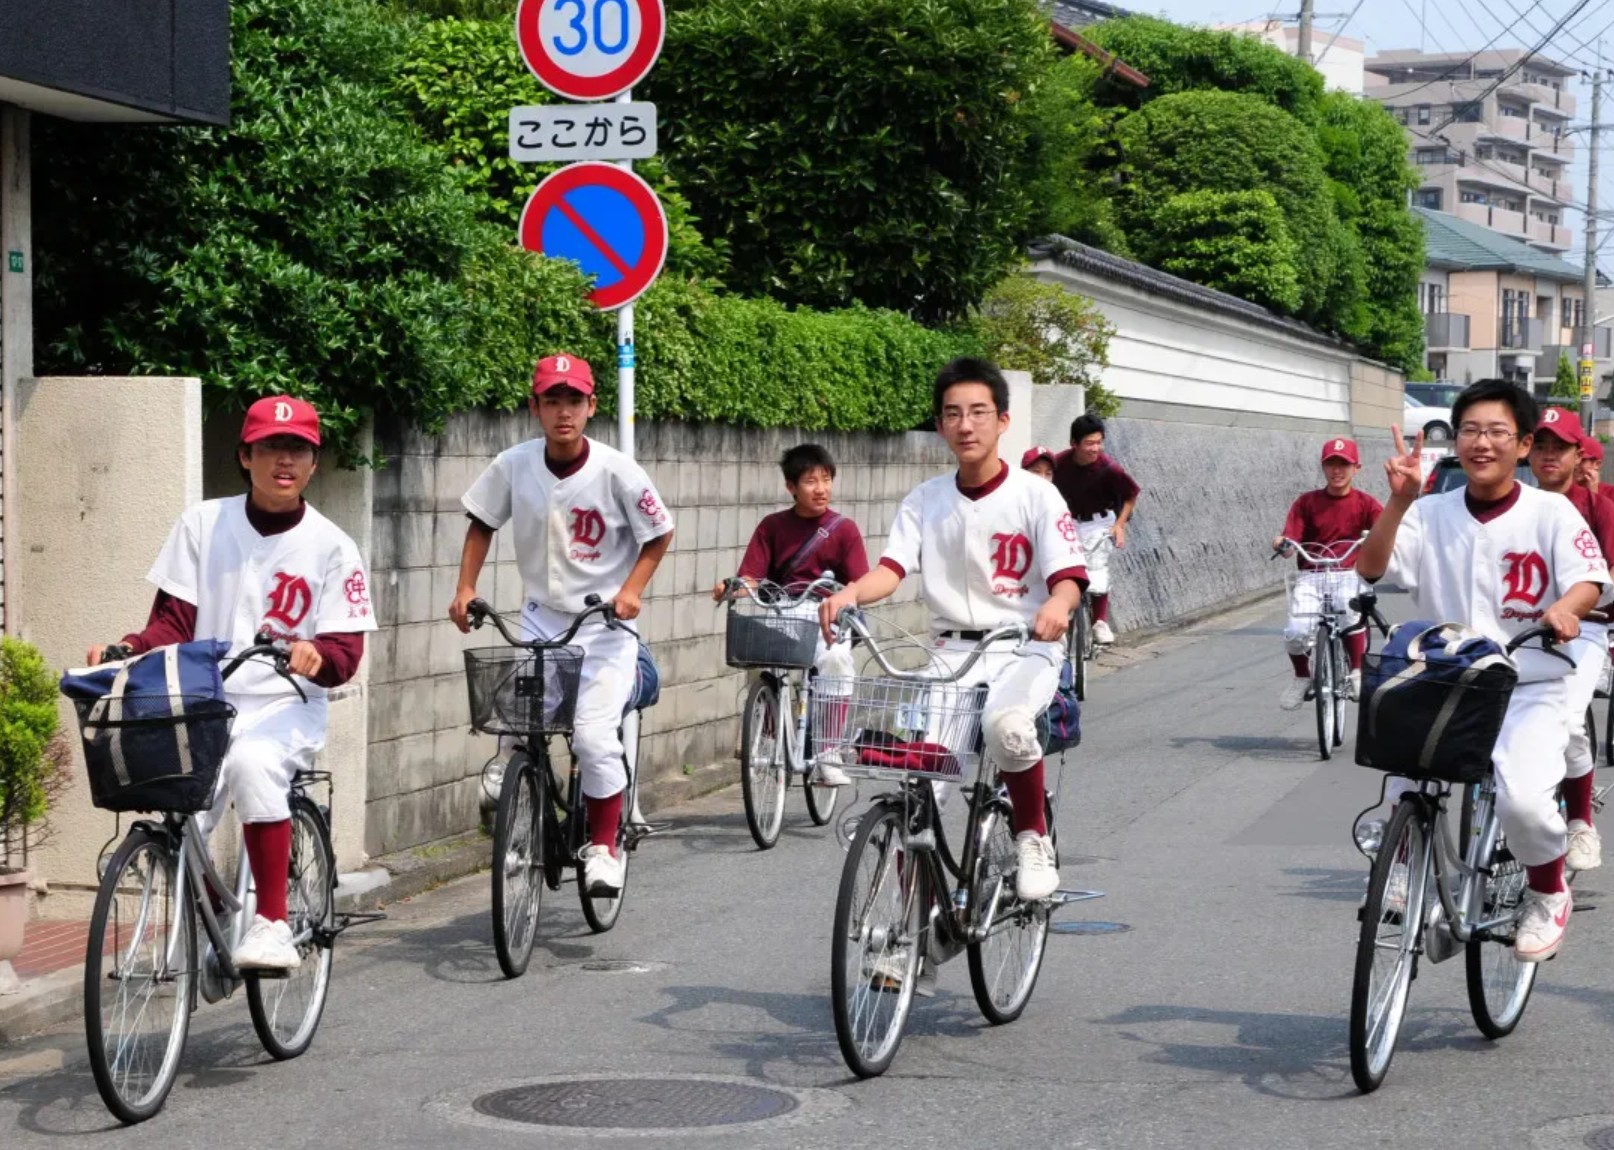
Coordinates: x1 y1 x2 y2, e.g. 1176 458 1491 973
89 395 376 971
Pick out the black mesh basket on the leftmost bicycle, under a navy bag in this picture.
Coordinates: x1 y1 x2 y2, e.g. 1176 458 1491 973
74 695 236 813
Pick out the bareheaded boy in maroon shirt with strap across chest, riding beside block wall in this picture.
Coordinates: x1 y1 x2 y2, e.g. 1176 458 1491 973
712 444 868 787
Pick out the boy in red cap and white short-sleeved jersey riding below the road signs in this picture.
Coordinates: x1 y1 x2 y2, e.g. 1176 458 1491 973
449 355 673 897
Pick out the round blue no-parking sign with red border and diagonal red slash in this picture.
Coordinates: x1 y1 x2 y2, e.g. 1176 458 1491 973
518 161 667 311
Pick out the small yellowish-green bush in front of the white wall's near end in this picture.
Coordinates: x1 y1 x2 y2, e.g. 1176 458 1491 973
973 273 1120 415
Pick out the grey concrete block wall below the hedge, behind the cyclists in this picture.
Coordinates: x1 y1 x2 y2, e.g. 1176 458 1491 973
365 411 949 855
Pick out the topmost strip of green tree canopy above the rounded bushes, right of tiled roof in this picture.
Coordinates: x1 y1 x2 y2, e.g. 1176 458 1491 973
1085 16 1323 124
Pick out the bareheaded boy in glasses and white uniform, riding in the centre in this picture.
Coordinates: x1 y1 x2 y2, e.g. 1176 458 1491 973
820 358 1088 902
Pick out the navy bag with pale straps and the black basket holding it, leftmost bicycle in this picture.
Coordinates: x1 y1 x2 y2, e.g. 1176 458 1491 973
61 639 236 811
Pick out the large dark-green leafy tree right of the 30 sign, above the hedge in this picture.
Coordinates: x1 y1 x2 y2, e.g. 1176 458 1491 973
642 0 1054 321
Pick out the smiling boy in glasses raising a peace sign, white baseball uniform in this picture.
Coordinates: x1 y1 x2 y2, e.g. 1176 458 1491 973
1356 379 1609 963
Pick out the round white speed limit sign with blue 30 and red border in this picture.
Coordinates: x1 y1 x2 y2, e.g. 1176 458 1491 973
515 0 667 100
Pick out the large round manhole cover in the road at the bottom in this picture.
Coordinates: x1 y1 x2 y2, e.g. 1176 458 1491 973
471 1077 801 1131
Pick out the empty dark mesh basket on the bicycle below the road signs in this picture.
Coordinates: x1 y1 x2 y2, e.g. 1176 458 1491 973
465 647 583 735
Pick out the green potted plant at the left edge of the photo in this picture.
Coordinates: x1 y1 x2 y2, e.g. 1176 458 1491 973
0 637 69 992
